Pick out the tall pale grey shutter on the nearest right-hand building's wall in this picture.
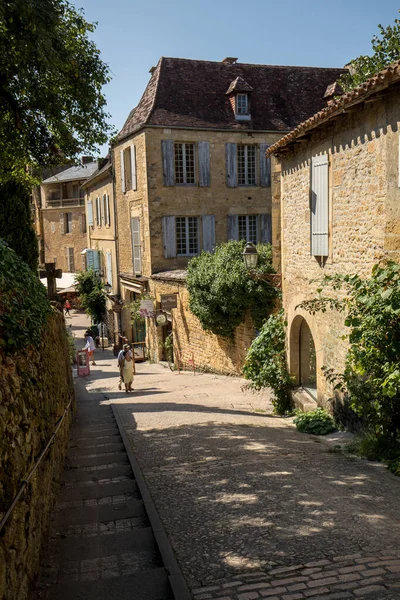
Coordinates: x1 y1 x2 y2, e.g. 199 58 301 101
311 154 329 256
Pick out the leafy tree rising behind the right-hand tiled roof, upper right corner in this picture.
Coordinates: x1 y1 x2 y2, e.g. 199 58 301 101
339 11 400 91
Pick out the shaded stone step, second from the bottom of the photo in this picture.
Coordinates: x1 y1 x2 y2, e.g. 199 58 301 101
49 527 161 571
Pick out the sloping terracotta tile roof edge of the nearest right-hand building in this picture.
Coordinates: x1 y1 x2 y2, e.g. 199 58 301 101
266 60 400 156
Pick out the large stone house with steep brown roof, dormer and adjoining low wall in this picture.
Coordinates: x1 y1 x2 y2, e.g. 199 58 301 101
113 58 343 372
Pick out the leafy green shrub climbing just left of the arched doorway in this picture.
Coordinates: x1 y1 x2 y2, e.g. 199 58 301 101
243 310 293 415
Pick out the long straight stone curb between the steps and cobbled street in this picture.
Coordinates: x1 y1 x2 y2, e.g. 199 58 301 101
111 403 192 600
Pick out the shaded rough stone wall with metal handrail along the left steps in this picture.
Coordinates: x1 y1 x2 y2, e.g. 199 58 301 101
0 314 74 600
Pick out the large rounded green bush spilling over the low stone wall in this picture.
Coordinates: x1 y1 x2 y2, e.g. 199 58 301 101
187 241 277 338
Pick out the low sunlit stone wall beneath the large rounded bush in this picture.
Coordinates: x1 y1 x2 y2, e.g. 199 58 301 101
147 280 254 375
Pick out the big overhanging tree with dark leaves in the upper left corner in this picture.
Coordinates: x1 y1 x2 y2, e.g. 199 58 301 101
0 0 110 183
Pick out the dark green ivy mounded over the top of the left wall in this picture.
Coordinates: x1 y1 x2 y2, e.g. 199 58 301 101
0 239 51 354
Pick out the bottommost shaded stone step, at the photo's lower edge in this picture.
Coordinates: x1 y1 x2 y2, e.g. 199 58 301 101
41 568 173 600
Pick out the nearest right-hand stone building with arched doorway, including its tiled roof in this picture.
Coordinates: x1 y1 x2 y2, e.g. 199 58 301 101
267 62 400 405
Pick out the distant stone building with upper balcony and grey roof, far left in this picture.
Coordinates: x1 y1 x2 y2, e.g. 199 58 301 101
38 157 98 273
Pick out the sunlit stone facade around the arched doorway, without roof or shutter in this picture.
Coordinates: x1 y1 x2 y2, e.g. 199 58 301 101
273 90 400 405
